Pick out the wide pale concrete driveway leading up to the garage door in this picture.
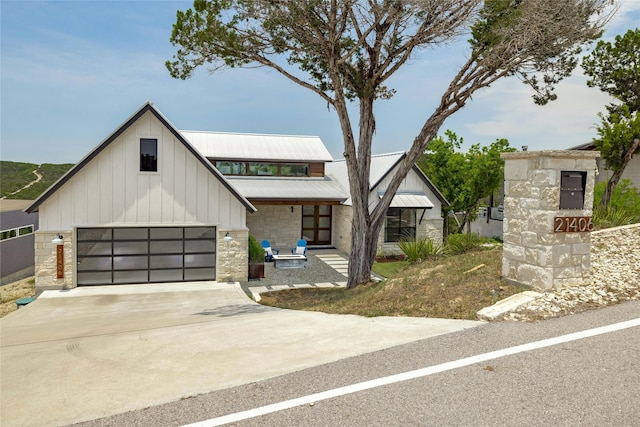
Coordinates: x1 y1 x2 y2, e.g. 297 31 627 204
0 282 481 426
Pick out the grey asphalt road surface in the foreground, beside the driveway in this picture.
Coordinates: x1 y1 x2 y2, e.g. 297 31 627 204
76 301 640 426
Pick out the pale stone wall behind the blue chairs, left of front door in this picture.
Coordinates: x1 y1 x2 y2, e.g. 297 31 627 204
247 205 302 251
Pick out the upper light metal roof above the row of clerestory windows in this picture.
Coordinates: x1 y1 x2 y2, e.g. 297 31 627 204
180 131 333 162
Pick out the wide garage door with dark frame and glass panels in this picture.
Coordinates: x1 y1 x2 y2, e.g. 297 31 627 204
76 227 216 286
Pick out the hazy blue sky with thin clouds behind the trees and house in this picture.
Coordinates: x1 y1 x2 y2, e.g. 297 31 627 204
0 0 640 163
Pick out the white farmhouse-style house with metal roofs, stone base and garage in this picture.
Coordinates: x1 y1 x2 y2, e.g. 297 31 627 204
26 102 447 288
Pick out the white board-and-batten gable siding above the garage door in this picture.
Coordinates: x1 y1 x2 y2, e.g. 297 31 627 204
39 112 246 231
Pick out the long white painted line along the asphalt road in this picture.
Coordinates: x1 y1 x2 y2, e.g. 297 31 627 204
183 318 640 427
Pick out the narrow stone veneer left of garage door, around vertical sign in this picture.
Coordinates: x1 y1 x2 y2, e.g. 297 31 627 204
34 231 75 289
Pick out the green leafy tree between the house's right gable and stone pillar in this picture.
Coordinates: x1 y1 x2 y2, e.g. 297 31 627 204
417 130 515 229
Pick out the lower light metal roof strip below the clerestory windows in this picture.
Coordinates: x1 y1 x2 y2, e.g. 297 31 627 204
227 176 349 202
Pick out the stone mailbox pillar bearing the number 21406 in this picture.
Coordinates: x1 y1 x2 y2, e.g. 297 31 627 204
502 150 600 290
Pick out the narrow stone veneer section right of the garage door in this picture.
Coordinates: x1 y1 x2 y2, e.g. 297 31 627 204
216 228 249 282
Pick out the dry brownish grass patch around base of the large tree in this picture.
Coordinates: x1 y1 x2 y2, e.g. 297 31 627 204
260 247 526 320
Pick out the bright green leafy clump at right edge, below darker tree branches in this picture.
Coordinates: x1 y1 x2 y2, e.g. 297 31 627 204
593 105 640 172
